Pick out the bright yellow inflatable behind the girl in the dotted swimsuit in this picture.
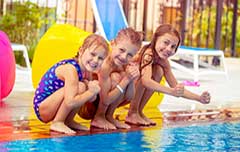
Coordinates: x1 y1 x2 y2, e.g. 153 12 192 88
32 24 91 88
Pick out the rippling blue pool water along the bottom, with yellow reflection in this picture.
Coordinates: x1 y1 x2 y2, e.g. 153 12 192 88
0 122 240 152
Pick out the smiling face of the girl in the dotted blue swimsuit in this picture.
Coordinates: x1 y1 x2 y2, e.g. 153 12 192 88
81 45 107 72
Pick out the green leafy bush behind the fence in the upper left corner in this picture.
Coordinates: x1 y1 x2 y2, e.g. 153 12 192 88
0 1 54 65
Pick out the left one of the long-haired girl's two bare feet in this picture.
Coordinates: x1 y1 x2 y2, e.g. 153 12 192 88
125 113 148 126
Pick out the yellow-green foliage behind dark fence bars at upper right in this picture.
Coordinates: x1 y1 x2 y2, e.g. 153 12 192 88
185 2 240 56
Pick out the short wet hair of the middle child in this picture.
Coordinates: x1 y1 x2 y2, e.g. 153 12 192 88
113 27 143 48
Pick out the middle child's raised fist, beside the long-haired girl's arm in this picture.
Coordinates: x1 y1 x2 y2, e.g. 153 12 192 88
126 63 140 81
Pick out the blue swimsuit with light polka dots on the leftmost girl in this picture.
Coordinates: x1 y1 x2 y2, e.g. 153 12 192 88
33 59 82 121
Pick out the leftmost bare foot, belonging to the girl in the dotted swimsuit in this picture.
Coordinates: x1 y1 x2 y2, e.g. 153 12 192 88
50 122 76 134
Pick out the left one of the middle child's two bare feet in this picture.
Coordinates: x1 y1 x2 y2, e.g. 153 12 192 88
91 117 117 130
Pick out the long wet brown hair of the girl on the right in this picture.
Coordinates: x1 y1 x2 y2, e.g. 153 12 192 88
139 24 181 74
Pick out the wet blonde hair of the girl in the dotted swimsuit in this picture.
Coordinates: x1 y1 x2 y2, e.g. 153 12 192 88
75 34 109 58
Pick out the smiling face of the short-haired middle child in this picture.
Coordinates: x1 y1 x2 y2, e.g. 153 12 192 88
112 40 139 66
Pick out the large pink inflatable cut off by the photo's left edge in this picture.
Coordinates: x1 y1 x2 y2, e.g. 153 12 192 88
0 31 16 101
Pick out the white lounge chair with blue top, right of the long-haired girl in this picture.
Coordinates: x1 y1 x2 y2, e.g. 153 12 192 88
170 46 228 81
